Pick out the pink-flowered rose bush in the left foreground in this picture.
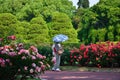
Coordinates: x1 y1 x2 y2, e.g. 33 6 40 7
0 36 50 80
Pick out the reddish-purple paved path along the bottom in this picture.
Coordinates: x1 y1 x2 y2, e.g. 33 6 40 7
41 71 120 80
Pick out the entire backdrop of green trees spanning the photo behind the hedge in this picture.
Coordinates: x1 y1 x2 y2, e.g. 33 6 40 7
0 0 120 45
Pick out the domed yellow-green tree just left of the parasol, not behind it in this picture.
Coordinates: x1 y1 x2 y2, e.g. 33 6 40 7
27 17 49 44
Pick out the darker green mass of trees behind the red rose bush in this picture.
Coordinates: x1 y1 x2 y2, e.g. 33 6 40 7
73 0 120 44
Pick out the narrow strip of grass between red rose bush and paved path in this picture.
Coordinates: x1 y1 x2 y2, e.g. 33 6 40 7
60 66 120 72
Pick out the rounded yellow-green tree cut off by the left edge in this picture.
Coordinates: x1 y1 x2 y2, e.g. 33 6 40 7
0 13 18 37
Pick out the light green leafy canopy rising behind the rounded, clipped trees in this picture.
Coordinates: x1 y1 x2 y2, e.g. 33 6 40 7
0 0 75 22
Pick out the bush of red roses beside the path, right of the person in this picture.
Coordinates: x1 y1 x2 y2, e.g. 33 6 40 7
70 41 120 68
